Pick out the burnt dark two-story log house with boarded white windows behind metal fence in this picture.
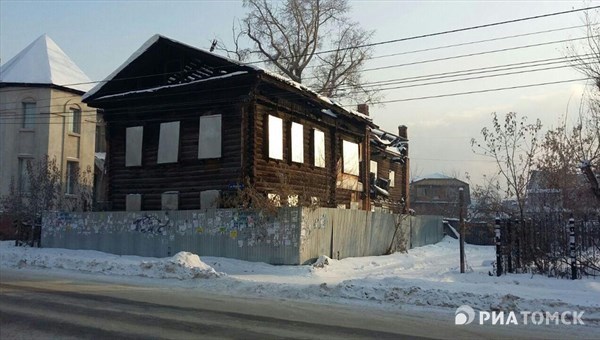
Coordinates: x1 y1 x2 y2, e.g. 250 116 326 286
84 35 376 210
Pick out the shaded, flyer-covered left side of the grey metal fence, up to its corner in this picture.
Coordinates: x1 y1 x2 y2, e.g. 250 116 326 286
42 208 301 264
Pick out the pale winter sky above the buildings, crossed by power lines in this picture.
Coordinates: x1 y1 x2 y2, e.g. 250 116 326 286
0 0 598 187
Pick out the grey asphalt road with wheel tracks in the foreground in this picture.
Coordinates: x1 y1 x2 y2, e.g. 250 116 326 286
0 268 594 340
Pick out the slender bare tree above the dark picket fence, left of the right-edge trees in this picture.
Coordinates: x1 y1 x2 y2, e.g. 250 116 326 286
471 112 542 220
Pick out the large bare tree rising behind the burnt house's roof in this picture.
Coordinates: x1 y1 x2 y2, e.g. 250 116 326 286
223 0 377 102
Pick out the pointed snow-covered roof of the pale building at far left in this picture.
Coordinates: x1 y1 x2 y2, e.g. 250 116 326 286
0 34 92 92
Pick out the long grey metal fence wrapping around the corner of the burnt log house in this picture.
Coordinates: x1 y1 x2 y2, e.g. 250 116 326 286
41 208 443 264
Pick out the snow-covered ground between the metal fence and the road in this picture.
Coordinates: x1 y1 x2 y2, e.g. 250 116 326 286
0 237 600 324
